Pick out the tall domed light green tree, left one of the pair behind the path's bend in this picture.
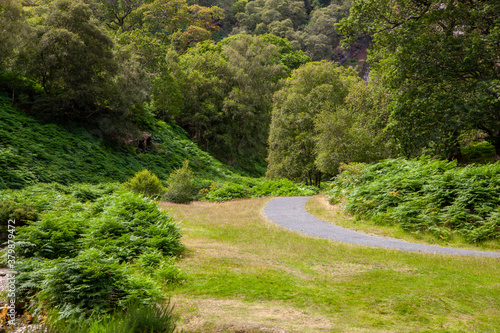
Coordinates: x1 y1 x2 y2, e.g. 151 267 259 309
266 61 356 186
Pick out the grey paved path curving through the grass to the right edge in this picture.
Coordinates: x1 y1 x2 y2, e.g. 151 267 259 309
264 197 500 258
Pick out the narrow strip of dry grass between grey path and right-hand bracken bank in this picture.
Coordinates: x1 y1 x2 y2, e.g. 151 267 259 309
306 195 500 251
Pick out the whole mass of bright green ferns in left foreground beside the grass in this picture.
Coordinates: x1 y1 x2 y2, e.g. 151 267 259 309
0 184 184 319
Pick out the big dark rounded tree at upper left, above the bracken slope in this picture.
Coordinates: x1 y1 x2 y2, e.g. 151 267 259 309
28 0 118 119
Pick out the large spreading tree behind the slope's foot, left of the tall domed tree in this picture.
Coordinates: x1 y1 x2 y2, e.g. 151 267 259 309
175 35 294 173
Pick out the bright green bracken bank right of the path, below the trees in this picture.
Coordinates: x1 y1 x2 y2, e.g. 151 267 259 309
327 157 500 242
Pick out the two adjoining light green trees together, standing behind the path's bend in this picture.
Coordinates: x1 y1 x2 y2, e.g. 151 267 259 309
266 61 387 186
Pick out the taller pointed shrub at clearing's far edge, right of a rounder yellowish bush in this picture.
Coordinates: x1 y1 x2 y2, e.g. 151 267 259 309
163 160 196 203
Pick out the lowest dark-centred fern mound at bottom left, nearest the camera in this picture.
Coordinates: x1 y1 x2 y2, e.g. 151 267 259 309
38 249 160 319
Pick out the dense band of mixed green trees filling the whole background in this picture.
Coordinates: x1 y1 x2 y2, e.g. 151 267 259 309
0 0 500 179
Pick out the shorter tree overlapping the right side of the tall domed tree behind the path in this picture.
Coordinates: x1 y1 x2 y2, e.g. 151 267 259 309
314 75 392 174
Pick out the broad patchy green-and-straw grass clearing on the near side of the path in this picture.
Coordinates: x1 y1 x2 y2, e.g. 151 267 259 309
163 198 500 332
